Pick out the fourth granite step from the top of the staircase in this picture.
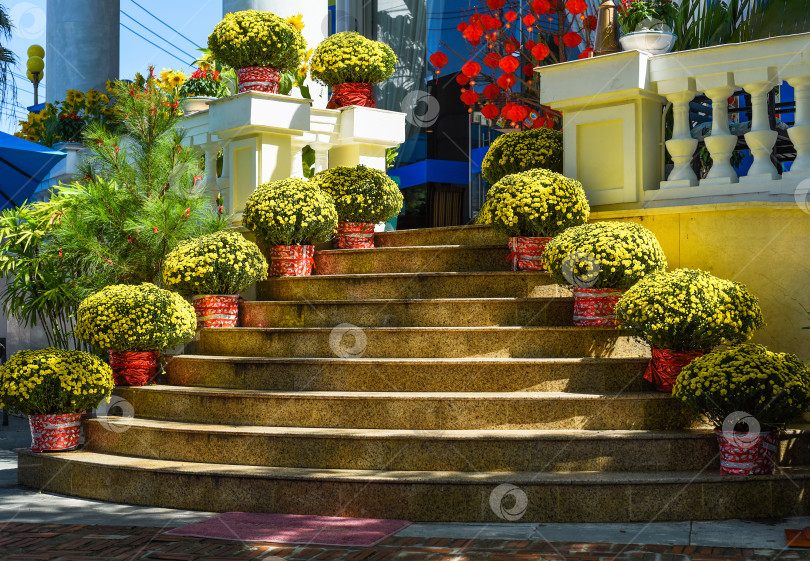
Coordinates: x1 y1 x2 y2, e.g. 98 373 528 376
239 297 574 327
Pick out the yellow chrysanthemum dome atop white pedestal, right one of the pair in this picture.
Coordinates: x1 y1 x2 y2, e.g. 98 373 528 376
311 31 397 86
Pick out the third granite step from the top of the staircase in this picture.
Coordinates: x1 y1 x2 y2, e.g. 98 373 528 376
256 271 571 301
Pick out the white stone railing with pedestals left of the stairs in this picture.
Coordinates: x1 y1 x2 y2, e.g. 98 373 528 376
182 92 405 221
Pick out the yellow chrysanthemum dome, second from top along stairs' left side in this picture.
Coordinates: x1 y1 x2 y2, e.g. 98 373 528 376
242 178 338 245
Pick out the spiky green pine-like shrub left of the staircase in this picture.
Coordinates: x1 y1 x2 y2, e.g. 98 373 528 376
39 78 227 289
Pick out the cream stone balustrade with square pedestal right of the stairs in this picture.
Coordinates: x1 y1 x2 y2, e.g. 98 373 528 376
537 33 810 209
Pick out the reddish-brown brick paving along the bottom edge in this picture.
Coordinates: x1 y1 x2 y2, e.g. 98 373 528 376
0 513 810 561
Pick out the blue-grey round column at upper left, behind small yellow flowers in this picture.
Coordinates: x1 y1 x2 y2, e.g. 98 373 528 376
45 0 120 103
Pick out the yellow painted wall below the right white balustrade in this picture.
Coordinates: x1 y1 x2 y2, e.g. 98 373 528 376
591 203 810 362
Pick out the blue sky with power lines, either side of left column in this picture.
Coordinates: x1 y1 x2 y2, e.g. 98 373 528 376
0 0 222 132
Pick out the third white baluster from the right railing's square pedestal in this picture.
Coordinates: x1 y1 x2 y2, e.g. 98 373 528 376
735 68 779 182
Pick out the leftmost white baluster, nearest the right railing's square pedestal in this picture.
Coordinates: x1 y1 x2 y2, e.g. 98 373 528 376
658 78 698 189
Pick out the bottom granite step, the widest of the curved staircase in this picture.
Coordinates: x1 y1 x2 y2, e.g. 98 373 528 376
17 450 810 522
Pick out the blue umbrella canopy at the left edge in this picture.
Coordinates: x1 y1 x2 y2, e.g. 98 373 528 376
0 132 66 210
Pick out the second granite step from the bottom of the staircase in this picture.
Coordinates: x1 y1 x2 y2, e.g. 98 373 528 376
84 417 732 472
